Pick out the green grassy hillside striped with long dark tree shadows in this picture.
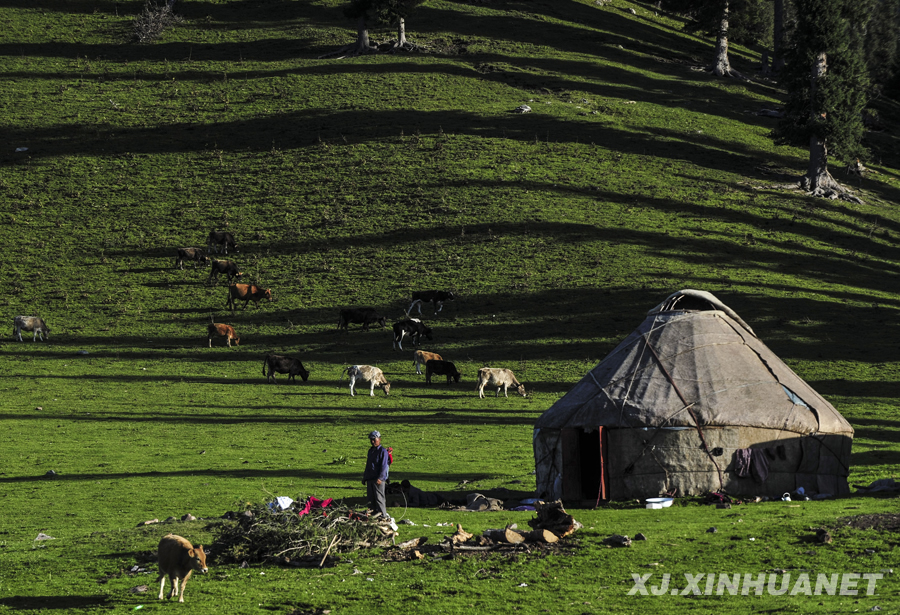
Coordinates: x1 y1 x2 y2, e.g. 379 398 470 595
0 0 900 614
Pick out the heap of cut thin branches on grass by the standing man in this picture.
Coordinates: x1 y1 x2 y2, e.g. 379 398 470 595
214 497 397 567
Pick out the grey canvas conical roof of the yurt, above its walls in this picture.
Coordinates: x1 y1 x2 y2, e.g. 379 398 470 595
535 290 853 436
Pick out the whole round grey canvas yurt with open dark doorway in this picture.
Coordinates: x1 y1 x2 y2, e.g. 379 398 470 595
534 290 853 502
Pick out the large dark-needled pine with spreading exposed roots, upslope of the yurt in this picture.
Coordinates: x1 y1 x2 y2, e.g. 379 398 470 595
773 0 868 200
